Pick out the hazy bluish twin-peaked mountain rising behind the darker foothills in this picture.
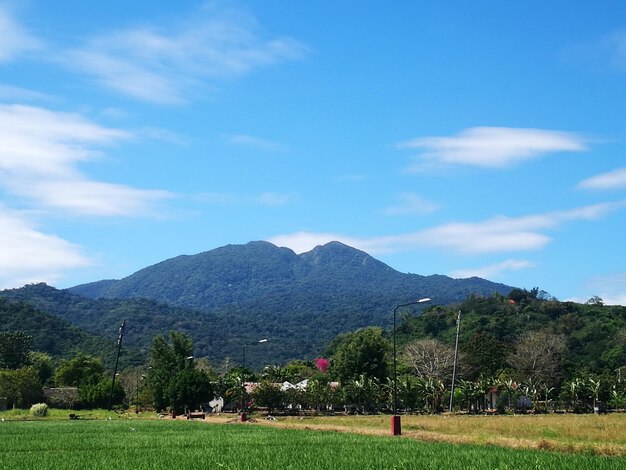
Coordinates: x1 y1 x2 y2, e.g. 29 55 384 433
69 242 511 313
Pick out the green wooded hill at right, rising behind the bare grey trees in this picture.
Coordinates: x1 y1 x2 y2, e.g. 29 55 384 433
398 289 626 383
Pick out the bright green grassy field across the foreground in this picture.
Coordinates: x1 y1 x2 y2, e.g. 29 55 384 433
0 418 626 470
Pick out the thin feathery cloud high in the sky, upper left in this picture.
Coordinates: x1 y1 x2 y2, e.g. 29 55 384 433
60 7 305 104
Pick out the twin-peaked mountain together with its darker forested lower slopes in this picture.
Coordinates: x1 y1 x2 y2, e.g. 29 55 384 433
0 242 512 366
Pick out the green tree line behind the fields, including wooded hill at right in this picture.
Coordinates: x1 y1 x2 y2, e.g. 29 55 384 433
0 289 626 413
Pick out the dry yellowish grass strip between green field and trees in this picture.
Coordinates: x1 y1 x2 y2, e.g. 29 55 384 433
207 413 626 456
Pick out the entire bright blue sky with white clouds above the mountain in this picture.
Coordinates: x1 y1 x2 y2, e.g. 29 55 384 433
0 0 626 305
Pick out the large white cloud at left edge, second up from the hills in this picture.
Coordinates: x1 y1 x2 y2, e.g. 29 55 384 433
0 105 170 216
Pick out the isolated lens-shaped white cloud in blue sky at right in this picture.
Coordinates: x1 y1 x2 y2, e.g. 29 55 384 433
400 127 587 171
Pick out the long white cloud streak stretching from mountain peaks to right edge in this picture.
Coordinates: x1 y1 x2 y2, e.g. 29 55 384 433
268 200 626 255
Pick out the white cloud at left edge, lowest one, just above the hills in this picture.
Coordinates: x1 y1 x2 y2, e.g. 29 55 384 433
0 206 91 288
